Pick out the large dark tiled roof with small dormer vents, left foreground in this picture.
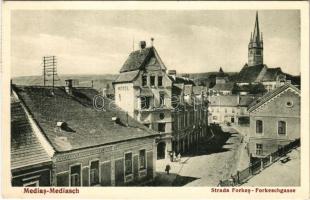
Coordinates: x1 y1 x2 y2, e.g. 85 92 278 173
15 86 157 152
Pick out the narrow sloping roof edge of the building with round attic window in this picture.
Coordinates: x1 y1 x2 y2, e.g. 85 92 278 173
248 83 300 112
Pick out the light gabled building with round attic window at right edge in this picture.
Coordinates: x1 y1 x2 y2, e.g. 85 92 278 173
249 83 300 157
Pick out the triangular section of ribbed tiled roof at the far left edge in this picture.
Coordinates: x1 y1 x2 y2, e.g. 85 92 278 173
11 98 51 170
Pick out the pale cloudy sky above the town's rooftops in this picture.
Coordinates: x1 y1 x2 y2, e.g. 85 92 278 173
11 10 300 77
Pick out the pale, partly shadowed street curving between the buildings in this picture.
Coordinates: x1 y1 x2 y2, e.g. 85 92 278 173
156 127 244 186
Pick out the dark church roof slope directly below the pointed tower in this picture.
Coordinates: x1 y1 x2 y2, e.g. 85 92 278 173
237 65 265 83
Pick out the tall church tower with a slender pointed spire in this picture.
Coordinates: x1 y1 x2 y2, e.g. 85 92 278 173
248 12 263 66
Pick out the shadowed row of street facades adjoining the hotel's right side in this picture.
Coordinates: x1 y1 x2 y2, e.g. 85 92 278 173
169 70 210 155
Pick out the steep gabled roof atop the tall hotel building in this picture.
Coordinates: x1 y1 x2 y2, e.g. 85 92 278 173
120 47 166 73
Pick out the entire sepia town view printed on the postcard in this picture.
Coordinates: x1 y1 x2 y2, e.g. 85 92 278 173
3 2 309 197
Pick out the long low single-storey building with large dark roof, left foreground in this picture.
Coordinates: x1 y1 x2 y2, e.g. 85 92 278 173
13 83 158 186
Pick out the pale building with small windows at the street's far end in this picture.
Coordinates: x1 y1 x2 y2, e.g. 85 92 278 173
209 95 255 125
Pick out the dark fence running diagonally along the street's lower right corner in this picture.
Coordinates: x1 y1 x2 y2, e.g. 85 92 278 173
218 139 300 186
